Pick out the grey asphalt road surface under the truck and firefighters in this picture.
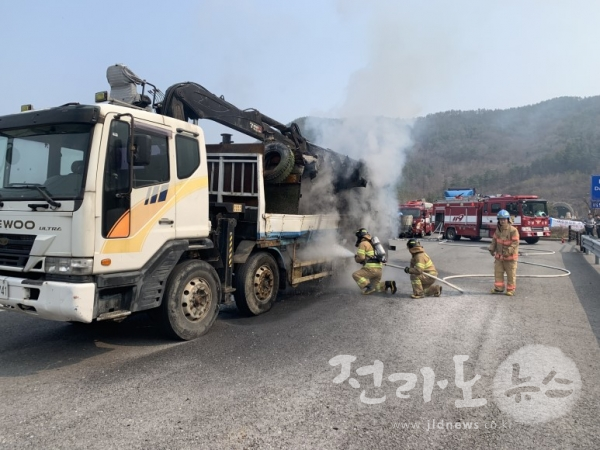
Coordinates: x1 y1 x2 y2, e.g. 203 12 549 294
0 237 600 449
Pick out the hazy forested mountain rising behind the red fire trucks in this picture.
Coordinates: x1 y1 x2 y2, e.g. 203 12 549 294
299 96 600 216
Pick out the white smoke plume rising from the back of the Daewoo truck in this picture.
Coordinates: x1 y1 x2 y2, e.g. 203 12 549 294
296 1 436 242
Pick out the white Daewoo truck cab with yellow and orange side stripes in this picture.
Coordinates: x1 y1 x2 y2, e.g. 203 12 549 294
0 104 211 322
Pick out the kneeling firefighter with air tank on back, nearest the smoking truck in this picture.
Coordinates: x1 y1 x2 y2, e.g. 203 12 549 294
352 228 397 295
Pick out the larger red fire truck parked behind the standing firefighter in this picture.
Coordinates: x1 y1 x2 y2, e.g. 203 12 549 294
433 195 550 244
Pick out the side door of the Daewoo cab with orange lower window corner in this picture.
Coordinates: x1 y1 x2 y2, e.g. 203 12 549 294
101 118 175 269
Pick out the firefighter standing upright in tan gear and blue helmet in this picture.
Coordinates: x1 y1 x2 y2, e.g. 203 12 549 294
488 209 519 296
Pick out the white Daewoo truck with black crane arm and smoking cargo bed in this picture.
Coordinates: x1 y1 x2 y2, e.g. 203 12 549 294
0 65 366 340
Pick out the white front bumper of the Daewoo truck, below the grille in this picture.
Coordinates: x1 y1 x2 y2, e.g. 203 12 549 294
0 277 96 323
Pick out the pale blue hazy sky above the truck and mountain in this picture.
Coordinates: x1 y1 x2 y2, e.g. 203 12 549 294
0 0 600 130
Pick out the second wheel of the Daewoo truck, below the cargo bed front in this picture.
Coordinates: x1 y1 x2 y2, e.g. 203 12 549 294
234 252 279 316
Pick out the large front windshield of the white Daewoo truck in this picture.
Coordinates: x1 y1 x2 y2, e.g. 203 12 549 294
0 124 92 201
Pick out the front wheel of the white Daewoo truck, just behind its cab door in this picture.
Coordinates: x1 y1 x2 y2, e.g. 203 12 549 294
156 260 221 341
